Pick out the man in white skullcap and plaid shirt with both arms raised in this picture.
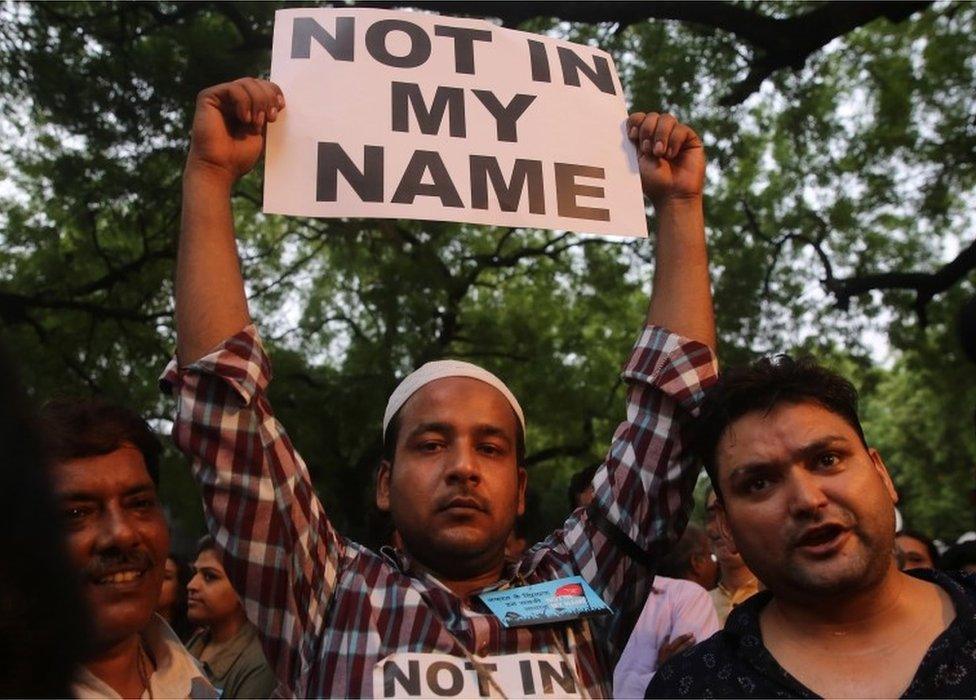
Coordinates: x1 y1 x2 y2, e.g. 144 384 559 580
164 78 715 697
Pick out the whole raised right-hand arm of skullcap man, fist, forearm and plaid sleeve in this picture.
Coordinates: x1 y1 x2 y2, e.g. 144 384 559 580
532 112 716 659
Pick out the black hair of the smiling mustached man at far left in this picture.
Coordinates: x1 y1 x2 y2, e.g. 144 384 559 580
40 398 163 486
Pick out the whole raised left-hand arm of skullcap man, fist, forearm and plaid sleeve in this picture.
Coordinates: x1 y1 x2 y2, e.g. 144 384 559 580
163 78 345 696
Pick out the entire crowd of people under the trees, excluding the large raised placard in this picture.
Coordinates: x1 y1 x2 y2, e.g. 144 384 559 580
0 78 976 698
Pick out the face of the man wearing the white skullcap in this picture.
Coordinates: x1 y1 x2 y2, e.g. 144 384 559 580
376 377 525 577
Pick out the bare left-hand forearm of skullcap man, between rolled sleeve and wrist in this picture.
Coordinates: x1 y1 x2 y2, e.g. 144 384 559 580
176 161 251 366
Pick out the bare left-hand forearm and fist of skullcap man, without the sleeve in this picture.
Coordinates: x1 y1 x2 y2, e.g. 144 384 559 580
176 78 285 365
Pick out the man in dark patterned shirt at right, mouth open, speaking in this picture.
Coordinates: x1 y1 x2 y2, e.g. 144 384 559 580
647 356 976 697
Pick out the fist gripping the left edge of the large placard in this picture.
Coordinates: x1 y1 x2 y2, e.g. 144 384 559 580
186 78 285 185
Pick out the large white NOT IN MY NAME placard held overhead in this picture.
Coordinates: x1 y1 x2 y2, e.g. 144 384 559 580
264 8 647 236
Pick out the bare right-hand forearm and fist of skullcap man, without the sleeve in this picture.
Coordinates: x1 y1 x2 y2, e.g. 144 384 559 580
628 112 715 350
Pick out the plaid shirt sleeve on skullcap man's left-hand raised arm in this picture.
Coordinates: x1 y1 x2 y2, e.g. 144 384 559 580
161 325 345 694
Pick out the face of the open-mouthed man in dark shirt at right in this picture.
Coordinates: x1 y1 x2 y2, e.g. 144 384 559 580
716 403 897 599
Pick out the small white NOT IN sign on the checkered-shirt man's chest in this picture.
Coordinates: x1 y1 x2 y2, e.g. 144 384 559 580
373 652 582 698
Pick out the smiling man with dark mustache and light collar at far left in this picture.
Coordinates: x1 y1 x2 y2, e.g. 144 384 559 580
41 399 216 698
